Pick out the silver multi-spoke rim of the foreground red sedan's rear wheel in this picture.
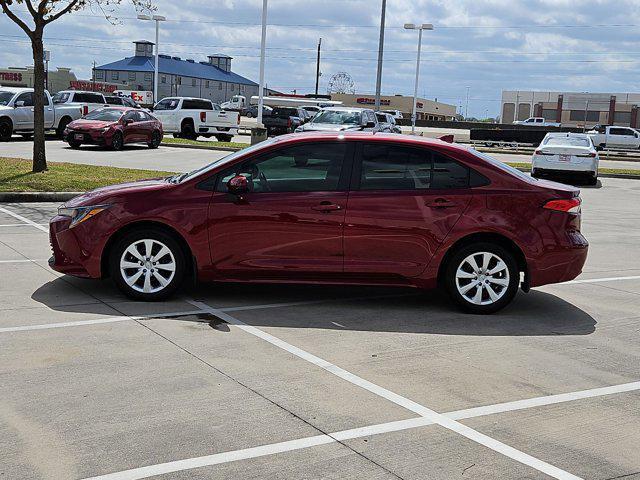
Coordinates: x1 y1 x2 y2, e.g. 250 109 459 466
455 252 510 305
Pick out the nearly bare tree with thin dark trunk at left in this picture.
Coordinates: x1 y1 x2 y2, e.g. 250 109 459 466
0 0 154 172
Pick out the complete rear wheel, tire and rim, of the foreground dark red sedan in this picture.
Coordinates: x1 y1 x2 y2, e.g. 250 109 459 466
444 242 520 314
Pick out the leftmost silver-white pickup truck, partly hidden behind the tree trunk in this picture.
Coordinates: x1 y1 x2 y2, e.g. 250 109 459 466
0 87 82 142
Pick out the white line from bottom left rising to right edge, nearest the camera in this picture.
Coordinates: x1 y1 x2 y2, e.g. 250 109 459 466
85 376 640 480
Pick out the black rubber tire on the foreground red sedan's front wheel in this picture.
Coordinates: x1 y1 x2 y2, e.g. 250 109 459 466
109 228 186 302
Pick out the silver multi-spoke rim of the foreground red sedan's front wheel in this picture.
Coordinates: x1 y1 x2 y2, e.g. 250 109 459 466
120 239 176 293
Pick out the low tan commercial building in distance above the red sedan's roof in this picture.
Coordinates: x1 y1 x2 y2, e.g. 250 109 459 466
331 93 456 120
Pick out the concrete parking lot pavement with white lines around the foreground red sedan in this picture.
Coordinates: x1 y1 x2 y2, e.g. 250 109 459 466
0 177 640 480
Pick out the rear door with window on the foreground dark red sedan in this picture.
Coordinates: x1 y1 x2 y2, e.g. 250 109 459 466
344 142 472 277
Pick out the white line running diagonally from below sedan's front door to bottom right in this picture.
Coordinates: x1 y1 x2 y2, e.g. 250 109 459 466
190 301 579 480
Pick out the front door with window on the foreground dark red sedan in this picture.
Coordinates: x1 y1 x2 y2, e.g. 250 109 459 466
209 142 352 278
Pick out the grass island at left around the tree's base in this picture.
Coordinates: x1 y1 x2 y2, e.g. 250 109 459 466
0 157 174 192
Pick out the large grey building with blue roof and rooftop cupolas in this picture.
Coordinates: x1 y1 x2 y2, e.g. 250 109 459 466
94 40 258 103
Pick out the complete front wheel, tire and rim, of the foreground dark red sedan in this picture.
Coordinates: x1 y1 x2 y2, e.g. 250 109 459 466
109 229 185 301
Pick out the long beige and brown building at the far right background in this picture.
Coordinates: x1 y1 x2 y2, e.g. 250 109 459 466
501 90 640 128
